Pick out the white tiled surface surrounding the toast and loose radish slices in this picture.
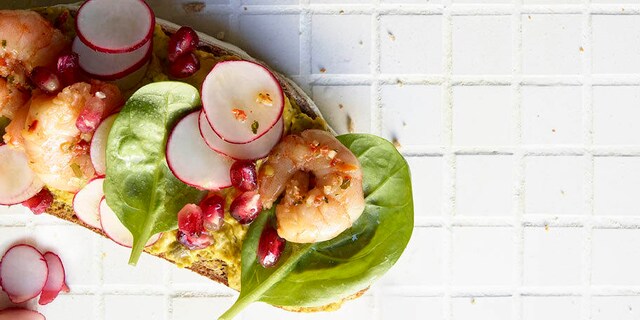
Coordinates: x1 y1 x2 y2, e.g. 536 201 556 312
0 0 640 320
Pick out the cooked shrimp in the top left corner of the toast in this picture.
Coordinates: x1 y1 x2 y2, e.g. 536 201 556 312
0 10 69 87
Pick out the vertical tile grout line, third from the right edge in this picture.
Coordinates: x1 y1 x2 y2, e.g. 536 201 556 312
441 0 456 320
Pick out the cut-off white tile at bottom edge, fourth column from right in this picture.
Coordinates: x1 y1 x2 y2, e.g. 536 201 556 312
380 296 443 320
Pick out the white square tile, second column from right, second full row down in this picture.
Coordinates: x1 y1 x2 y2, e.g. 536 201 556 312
521 86 583 145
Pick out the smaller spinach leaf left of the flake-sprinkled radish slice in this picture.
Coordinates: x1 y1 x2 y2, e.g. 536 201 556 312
104 82 204 265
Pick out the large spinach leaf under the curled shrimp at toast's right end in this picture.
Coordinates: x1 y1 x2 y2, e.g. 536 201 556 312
220 134 413 319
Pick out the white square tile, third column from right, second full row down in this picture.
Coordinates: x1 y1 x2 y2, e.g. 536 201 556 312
453 86 515 146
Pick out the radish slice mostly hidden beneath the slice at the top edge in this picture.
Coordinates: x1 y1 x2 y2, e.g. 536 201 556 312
72 36 153 80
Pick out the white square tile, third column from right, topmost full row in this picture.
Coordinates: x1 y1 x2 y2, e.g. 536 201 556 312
453 15 512 74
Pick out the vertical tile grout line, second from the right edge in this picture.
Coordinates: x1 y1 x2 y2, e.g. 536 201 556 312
511 0 526 320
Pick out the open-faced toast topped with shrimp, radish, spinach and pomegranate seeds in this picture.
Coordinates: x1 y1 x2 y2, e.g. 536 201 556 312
0 0 413 319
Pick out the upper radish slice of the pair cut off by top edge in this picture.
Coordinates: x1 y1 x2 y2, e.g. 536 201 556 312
76 0 155 53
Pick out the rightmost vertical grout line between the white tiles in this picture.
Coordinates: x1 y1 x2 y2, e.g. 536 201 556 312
580 0 594 320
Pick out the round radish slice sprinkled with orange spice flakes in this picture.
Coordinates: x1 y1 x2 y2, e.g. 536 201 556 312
202 61 284 144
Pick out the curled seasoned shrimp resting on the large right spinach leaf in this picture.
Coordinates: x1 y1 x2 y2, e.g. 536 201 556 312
258 130 364 243
